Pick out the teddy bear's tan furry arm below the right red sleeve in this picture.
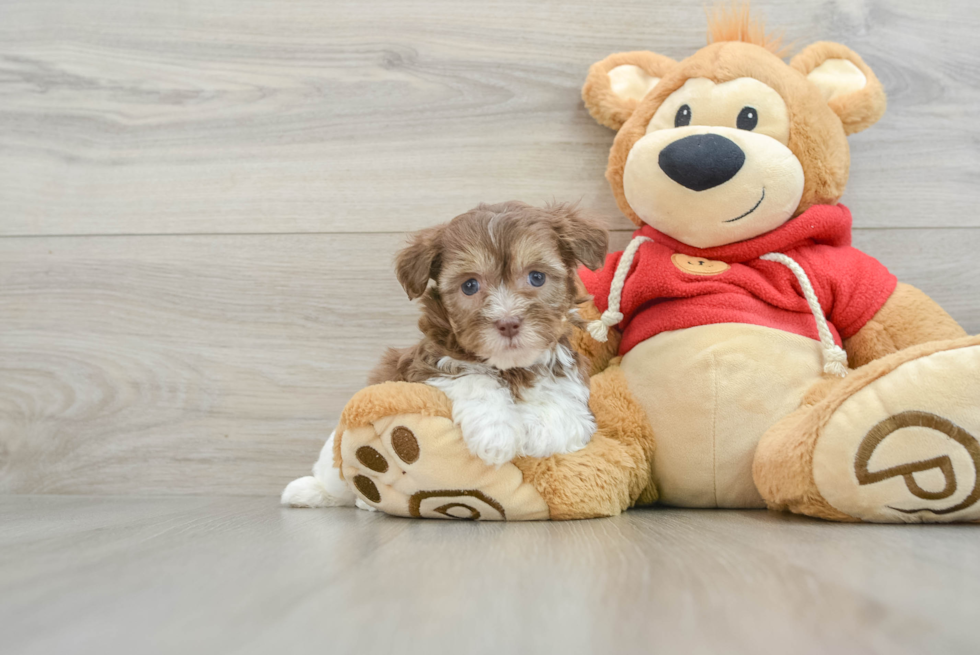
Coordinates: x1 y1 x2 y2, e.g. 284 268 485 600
844 283 966 368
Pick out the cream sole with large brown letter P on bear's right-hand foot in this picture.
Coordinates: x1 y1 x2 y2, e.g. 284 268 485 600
813 339 980 523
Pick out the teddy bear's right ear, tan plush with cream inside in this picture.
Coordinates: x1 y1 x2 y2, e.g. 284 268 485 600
790 41 887 134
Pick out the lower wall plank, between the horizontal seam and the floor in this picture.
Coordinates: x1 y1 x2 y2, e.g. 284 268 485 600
0 230 980 495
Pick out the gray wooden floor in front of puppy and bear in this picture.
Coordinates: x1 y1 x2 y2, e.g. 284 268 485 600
0 496 980 655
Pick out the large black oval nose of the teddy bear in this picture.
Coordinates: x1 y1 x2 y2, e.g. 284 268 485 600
660 134 745 191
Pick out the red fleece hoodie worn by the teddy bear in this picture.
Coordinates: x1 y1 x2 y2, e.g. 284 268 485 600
579 205 897 355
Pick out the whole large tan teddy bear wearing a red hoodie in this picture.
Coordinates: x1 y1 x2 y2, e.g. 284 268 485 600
334 11 980 523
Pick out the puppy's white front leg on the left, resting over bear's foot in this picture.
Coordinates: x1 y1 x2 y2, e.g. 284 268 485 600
427 374 524 466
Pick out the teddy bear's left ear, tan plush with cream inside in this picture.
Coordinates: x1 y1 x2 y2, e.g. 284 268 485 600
582 51 677 130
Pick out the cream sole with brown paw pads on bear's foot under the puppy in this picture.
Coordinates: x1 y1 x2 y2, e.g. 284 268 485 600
340 414 549 521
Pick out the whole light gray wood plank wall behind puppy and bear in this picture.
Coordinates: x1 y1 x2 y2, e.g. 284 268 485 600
0 0 980 494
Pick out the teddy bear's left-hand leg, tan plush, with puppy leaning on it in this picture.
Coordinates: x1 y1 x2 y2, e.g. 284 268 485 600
335 367 655 520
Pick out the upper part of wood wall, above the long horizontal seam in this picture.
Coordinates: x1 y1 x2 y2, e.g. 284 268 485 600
0 0 980 235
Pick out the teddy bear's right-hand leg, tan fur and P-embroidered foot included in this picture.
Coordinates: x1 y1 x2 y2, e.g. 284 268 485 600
753 337 980 523
